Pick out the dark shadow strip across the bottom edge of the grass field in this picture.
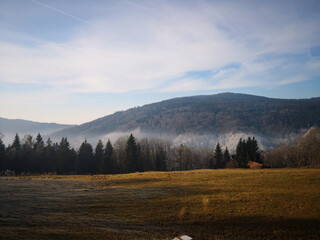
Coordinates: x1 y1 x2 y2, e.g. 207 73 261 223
0 216 320 240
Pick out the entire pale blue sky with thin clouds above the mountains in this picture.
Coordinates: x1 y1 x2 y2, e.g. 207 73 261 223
0 0 320 124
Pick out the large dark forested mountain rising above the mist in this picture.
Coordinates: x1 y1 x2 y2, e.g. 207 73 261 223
53 93 320 149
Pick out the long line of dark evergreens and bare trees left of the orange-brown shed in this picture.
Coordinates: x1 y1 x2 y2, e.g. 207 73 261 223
0 134 262 174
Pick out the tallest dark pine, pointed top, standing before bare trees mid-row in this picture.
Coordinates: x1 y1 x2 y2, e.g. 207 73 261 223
124 133 138 172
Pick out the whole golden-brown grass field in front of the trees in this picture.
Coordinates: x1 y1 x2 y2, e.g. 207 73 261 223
0 169 320 240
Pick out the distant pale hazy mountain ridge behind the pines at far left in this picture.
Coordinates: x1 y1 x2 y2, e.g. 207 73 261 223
0 117 74 143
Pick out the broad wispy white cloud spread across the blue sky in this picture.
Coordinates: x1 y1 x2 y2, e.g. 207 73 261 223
0 2 320 92
